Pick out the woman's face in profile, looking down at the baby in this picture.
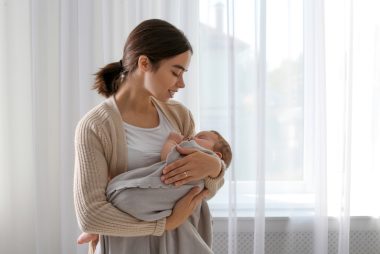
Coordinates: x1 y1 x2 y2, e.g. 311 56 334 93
144 51 191 101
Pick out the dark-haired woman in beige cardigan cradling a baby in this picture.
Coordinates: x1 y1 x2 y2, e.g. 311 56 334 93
74 19 225 253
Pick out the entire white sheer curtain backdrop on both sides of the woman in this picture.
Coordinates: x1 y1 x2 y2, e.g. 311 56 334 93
0 0 380 254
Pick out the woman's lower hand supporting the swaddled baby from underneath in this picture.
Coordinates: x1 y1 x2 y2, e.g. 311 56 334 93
165 187 209 230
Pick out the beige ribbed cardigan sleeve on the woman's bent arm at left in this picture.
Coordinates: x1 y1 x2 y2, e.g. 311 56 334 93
74 118 166 236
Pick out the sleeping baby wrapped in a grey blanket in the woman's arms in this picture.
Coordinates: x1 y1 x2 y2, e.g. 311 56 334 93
77 131 232 244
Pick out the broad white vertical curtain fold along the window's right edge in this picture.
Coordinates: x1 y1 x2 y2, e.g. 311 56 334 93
304 1 328 254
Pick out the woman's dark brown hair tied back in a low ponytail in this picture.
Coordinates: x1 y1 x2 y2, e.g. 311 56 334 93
93 19 193 97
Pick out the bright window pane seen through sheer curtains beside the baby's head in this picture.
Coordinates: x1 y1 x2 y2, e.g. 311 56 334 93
199 0 311 216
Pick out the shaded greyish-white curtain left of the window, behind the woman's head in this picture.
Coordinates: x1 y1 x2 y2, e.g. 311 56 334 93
0 0 198 254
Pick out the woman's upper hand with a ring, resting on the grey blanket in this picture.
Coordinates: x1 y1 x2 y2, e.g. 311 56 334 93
161 146 221 186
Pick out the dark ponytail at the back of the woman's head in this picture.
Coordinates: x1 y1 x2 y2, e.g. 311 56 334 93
93 61 125 98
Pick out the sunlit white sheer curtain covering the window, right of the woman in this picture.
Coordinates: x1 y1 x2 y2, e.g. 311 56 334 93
199 0 380 254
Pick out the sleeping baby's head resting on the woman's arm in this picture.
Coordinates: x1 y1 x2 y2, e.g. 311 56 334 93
194 131 232 168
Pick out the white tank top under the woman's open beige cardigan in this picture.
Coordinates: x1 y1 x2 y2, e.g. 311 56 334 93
123 108 174 170
